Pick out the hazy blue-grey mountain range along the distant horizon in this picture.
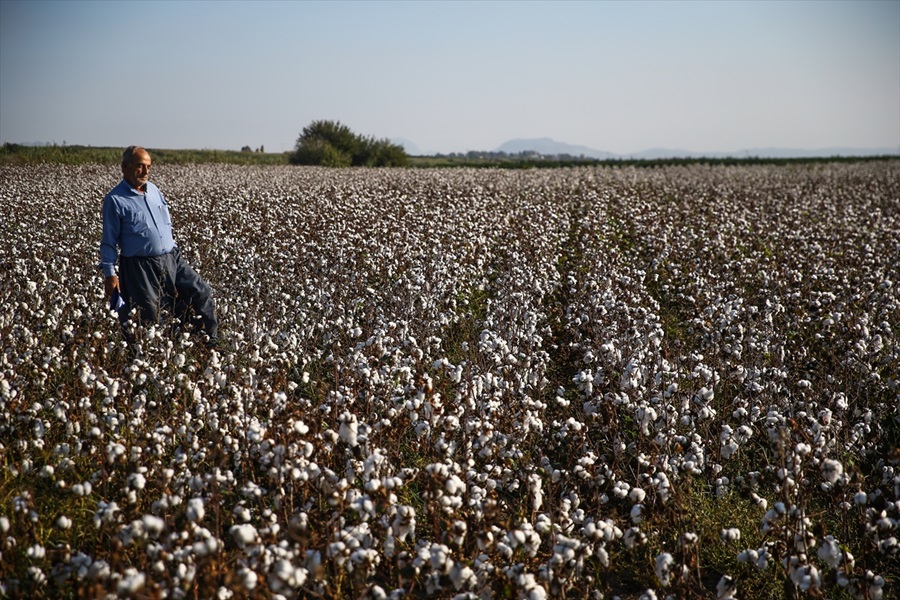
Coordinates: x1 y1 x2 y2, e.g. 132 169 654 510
391 138 900 160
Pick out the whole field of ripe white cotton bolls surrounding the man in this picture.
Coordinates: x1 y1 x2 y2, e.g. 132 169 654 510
0 161 900 600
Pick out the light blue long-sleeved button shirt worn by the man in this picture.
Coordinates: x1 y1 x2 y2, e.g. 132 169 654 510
100 179 175 277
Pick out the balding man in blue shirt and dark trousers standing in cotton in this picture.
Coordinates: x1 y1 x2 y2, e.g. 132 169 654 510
99 146 219 347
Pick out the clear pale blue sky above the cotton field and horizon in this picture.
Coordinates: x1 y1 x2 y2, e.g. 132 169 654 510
0 0 900 153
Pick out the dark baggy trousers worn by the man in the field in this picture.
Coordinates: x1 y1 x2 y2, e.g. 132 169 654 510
119 248 219 342
